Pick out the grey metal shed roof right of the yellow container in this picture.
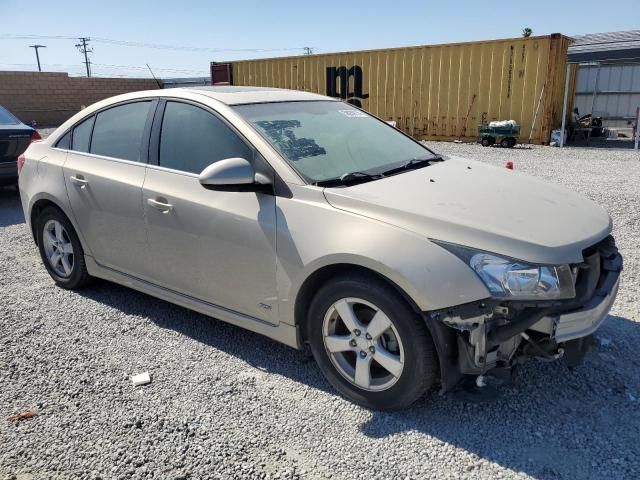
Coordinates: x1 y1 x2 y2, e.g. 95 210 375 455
569 30 640 63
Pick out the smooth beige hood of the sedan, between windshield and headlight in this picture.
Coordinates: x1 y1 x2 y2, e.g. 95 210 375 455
324 157 612 264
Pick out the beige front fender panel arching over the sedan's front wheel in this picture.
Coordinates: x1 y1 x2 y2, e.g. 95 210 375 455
276 187 489 325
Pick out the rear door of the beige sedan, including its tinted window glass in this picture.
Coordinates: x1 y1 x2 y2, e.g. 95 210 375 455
64 100 157 275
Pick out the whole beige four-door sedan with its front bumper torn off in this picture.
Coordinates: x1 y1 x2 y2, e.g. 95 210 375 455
18 87 622 409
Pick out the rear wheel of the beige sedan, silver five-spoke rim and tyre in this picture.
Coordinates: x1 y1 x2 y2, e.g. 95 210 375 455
36 207 92 290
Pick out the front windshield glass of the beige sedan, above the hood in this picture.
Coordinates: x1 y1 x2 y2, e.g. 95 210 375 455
235 101 434 183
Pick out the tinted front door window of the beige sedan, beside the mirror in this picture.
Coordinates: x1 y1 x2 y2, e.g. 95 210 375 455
160 102 252 173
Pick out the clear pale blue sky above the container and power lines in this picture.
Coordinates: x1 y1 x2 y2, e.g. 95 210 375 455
0 0 640 77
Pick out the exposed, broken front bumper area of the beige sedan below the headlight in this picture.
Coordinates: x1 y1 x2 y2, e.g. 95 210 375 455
425 237 622 393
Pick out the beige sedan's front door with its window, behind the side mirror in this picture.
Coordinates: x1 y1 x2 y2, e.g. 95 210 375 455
143 101 277 323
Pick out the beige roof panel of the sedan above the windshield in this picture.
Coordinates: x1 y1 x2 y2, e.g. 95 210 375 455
175 86 339 105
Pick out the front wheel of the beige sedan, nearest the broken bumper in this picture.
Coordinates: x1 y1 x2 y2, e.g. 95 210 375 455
307 274 438 410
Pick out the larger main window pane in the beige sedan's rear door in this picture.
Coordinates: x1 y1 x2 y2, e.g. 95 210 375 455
91 101 151 162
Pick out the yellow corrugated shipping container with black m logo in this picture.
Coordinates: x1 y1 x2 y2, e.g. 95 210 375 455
232 34 570 143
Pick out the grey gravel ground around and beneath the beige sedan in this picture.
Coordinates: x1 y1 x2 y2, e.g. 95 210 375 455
0 138 640 479
